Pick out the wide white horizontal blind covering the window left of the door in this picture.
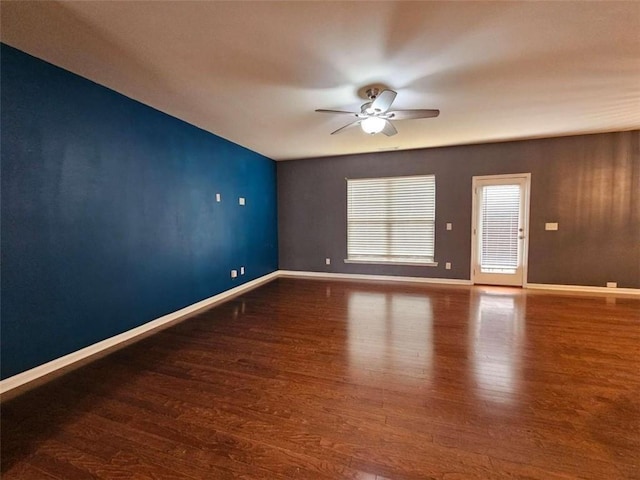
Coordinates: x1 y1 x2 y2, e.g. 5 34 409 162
347 175 436 263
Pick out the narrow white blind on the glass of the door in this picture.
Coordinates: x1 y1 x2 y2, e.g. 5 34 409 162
480 185 520 273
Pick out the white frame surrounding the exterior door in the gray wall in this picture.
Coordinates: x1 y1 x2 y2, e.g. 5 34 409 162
469 173 531 288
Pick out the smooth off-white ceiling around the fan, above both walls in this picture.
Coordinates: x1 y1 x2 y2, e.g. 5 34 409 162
1 0 640 160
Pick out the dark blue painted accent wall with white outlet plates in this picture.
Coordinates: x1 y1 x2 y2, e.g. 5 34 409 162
0 45 278 378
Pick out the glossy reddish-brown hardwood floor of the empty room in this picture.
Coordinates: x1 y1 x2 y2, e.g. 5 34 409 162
1 278 640 480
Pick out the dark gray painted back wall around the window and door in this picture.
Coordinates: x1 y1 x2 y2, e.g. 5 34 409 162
277 130 640 288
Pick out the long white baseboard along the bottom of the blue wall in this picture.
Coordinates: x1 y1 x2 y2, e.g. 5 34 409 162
0 271 279 395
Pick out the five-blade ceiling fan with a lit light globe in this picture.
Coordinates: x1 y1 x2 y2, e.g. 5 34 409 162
316 87 440 137
